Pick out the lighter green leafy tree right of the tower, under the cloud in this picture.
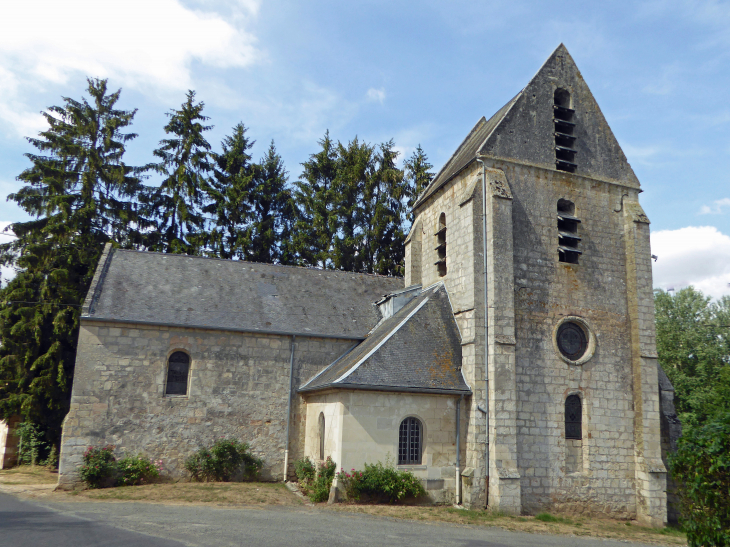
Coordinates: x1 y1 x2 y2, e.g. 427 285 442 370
654 287 730 428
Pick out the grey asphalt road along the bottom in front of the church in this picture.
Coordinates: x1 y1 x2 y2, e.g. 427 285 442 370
0 494 664 547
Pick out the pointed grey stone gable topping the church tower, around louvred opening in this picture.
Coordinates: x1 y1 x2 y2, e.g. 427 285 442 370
480 44 639 188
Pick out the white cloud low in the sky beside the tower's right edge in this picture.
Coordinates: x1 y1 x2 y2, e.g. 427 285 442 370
651 226 730 298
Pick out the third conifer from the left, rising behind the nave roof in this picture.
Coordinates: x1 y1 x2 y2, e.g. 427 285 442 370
204 123 255 258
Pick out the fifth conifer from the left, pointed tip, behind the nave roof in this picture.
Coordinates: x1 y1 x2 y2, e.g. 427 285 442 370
292 131 338 268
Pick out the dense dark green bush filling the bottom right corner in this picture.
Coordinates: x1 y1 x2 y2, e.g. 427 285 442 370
669 412 730 547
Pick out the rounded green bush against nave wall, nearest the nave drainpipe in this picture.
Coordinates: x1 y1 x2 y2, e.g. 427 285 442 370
185 439 264 482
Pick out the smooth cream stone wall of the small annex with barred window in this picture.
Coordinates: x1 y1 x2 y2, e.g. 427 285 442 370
304 390 466 503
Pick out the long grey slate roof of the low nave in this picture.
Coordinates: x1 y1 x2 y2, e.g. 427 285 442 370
82 249 403 340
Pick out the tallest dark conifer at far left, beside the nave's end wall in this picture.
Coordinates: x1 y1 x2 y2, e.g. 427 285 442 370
0 79 147 443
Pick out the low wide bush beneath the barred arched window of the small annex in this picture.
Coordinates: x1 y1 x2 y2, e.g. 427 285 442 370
337 462 426 503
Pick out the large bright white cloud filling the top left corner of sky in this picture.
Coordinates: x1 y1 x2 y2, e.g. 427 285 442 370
0 0 263 134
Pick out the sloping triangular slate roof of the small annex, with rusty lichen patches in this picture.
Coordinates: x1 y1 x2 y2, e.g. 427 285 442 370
299 283 471 394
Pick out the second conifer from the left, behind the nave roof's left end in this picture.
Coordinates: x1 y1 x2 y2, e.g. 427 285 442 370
148 90 213 255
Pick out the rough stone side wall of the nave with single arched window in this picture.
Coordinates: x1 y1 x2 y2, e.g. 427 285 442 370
59 320 355 488
